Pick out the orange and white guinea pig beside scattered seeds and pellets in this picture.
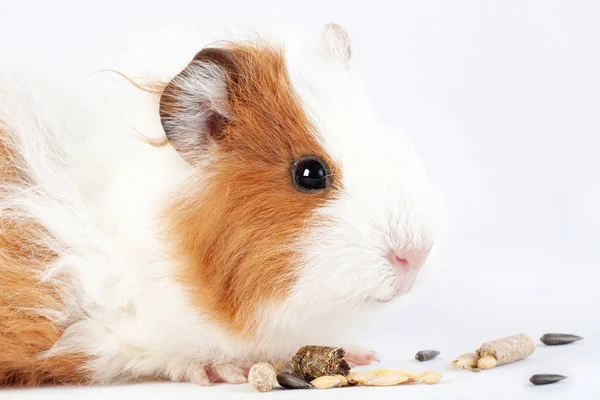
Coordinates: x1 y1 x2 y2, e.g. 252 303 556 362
0 24 440 386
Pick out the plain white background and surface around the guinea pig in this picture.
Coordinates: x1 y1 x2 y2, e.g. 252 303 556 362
0 0 600 399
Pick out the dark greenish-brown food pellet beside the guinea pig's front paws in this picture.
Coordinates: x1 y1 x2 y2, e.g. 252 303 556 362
291 346 350 381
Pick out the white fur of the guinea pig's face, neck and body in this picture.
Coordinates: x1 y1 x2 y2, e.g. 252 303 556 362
0 25 439 383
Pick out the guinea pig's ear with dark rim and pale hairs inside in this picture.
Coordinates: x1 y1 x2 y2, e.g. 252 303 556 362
159 48 236 165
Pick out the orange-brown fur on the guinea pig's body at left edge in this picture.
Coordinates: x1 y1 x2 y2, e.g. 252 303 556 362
0 121 87 386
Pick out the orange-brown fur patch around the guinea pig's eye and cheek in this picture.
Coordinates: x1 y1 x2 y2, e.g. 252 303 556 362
166 44 340 335
